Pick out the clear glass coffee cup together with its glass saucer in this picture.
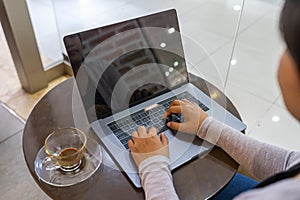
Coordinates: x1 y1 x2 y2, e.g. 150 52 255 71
34 128 102 187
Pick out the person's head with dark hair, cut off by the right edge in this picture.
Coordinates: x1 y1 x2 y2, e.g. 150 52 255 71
278 0 300 121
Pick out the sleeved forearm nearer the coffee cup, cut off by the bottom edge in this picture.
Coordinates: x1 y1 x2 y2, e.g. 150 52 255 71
139 156 178 200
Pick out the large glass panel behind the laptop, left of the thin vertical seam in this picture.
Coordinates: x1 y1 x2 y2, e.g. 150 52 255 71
50 0 244 90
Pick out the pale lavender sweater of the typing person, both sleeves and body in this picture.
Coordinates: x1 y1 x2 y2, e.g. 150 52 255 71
139 117 300 199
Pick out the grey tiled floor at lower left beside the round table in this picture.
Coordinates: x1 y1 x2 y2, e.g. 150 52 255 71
0 103 49 200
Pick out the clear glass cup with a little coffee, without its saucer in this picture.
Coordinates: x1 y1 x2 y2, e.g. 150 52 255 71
43 128 87 173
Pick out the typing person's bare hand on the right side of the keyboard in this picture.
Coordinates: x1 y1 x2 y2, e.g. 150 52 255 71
164 99 208 134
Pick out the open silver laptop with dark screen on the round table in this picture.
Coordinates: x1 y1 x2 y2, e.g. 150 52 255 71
64 9 246 188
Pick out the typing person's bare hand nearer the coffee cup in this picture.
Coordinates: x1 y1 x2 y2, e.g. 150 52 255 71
128 126 169 166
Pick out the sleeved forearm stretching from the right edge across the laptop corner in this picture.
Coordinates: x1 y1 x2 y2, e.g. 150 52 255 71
198 118 296 179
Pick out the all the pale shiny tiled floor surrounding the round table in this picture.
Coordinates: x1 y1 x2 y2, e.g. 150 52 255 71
0 0 300 199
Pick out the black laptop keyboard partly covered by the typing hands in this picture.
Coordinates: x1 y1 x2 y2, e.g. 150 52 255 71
108 92 209 149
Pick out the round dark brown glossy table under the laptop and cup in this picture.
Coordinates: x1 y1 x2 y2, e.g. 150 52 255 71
23 74 240 200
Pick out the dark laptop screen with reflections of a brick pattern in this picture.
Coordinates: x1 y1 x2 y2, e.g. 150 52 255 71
64 10 188 122
